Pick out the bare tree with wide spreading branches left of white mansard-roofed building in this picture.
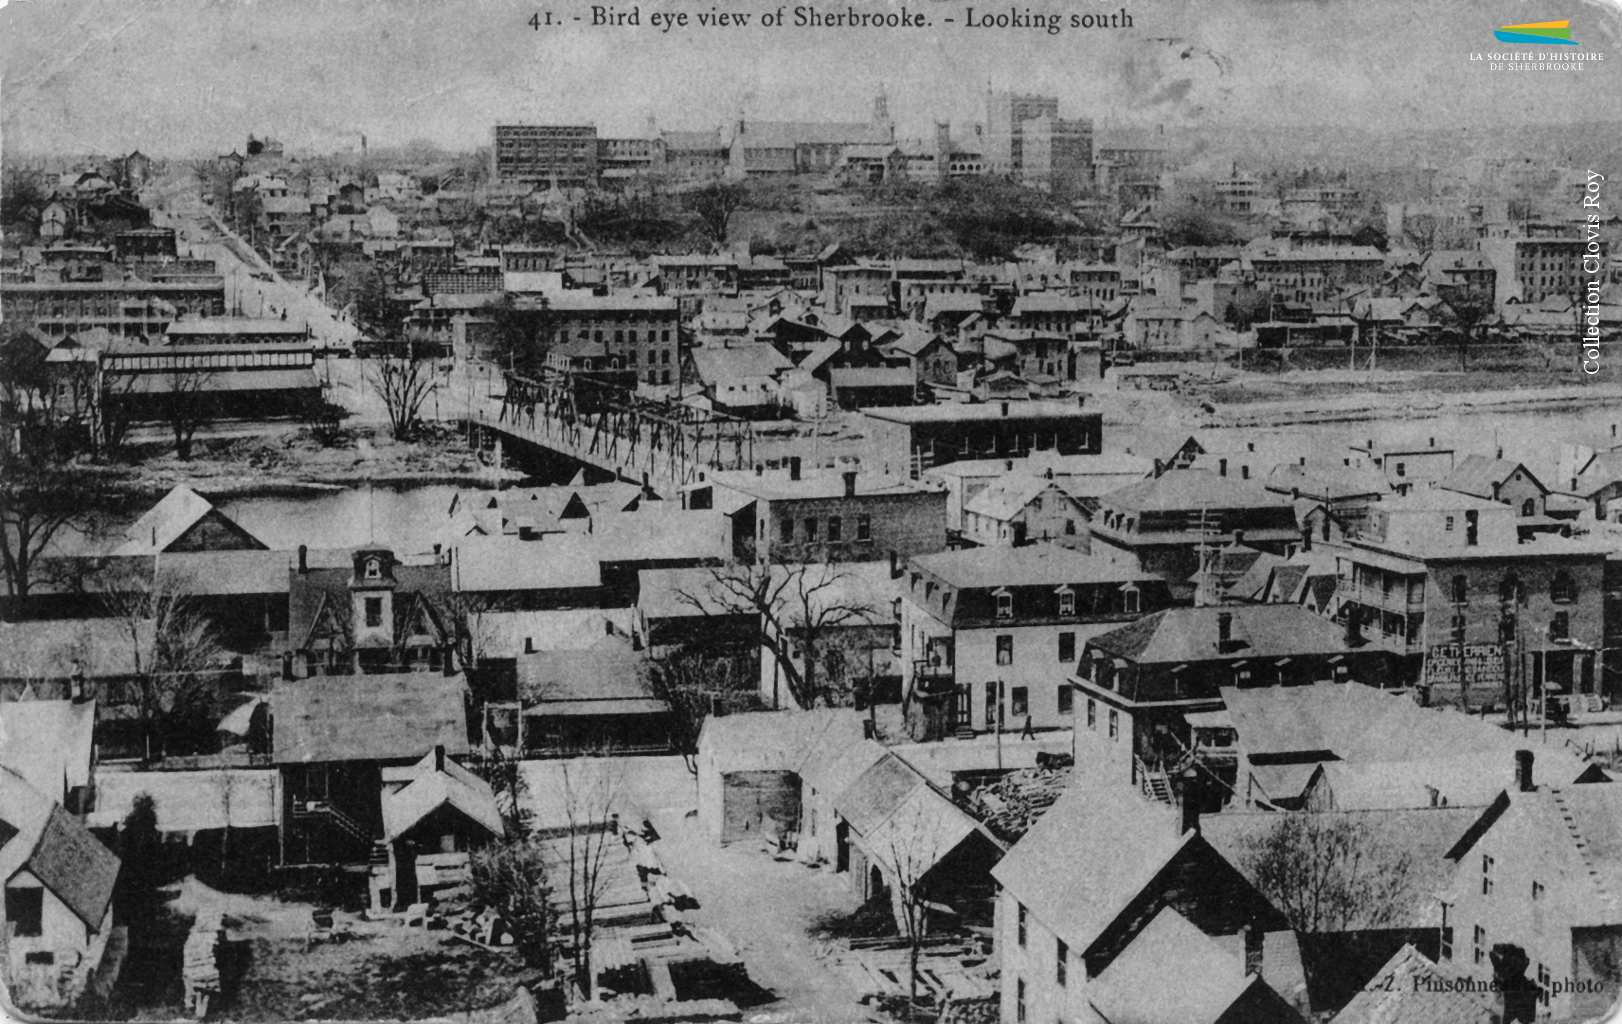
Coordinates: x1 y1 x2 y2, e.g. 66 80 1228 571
676 563 879 708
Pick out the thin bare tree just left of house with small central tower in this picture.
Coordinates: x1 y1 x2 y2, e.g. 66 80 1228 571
101 573 224 759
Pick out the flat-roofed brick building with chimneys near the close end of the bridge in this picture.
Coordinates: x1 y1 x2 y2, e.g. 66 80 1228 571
686 456 946 563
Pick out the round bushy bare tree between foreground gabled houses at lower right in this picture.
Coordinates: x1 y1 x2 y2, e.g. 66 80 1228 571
1238 811 1421 931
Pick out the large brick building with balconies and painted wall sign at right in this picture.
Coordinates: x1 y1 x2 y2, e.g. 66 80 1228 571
1335 488 1606 708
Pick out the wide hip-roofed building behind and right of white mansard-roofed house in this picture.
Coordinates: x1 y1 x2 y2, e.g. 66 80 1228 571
1090 469 1301 596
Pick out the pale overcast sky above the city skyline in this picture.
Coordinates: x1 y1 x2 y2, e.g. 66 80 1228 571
0 0 1622 154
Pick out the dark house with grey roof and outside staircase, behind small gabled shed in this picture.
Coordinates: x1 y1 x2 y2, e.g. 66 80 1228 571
271 672 469 863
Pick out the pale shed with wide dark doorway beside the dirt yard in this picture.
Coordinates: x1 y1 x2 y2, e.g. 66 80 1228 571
694 708 863 845
